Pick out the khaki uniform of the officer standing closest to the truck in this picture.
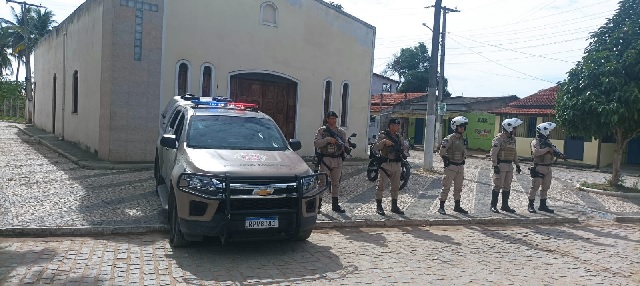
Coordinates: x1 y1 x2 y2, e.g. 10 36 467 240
313 126 347 198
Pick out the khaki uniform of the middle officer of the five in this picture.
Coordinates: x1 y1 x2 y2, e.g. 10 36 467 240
440 132 467 202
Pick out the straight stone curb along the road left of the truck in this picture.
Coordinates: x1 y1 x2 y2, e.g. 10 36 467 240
0 225 169 237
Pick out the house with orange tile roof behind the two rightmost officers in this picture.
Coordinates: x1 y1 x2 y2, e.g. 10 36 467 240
490 86 640 167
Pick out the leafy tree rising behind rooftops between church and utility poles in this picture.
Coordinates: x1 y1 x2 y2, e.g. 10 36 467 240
383 42 451 97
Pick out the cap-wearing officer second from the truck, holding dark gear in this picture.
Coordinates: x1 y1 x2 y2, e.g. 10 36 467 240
373 118 406 215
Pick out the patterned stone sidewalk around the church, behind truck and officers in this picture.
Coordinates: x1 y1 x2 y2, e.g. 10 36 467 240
0 122 640 236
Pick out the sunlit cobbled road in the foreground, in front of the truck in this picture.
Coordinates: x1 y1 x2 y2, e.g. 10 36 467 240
0 223 640 285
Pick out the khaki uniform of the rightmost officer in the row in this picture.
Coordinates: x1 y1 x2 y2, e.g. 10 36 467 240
529 138 554 201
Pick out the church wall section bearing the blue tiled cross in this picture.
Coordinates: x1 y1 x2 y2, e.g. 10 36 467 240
99 0 164 161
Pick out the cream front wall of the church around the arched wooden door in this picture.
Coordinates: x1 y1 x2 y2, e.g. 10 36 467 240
156 0 375 157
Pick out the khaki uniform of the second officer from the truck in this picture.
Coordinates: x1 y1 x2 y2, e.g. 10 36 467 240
373 132 404 200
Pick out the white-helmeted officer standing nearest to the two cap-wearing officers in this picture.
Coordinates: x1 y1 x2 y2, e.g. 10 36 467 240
438 116 469 215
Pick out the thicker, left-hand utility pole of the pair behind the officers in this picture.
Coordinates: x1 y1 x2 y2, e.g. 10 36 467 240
422 0 442 170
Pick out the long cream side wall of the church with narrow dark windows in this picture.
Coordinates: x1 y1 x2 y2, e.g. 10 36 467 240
34 0 103 152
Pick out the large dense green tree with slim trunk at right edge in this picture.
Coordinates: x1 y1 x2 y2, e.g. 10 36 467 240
556 0 640 186
